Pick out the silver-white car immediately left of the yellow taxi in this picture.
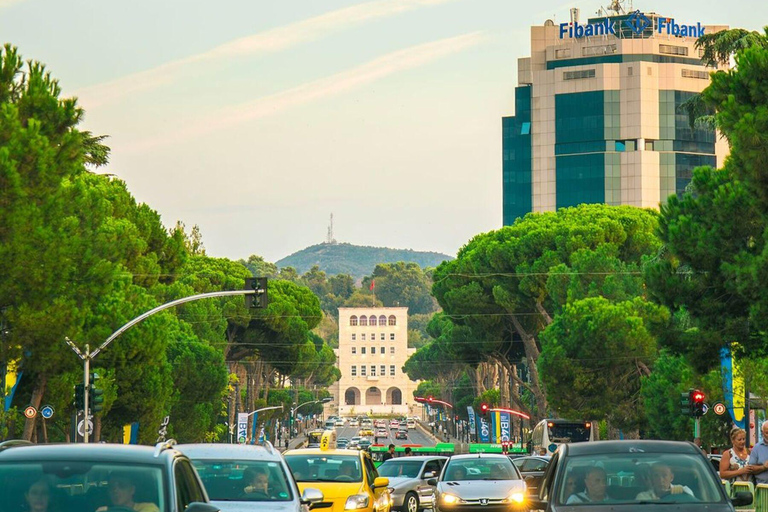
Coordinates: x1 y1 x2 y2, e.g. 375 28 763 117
176 443 323 512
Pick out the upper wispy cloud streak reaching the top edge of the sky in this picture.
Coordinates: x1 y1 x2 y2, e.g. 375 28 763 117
72 0 454 108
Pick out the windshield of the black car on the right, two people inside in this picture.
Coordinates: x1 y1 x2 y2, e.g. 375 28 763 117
557 452 723 506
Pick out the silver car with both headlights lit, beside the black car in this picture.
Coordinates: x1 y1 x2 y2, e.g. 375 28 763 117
428 453 526 512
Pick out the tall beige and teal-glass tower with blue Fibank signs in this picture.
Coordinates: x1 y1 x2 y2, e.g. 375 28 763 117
502 9 728 225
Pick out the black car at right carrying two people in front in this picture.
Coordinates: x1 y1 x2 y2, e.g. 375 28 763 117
530 440 752 512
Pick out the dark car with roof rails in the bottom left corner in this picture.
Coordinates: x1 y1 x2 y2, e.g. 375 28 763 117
0 440 219 512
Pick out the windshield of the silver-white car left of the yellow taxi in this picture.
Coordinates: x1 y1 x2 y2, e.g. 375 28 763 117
192 460 293 501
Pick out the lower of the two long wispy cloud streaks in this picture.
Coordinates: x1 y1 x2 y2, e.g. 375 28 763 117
122 32 488 152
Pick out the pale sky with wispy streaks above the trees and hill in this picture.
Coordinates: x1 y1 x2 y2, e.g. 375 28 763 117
0 0 768 261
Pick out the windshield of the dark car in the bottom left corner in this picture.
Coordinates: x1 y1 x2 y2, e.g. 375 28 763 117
0 461 169 512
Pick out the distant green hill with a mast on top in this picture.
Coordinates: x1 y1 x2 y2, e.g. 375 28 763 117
275 243 453 278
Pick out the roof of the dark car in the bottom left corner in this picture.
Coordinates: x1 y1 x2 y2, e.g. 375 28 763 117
0 443 181 465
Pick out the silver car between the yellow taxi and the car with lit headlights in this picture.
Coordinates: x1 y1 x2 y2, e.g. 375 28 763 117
379 455 448 512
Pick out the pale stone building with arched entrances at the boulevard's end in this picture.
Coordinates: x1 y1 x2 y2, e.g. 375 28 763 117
329 308 421 416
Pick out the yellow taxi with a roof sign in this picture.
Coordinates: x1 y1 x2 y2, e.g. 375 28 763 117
283 431 392 512
